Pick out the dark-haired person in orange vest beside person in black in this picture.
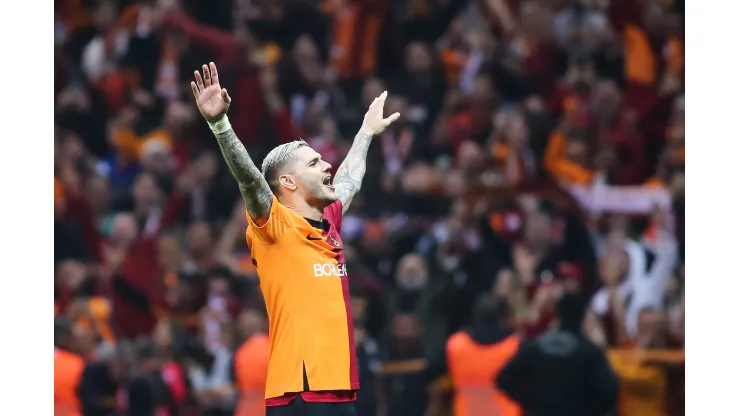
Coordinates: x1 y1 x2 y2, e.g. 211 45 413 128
447 295 521 416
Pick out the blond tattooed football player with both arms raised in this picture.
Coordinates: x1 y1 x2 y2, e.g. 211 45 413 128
190 62 401 414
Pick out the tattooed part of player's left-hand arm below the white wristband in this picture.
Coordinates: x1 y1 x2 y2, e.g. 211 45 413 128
216 129 272 222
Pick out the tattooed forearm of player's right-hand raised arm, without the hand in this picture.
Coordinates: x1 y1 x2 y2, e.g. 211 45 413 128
334 133 373 212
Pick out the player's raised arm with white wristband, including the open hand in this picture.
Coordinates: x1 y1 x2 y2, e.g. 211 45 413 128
190 62 272 225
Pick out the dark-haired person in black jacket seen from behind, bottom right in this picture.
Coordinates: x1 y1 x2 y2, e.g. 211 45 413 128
496 292 619 416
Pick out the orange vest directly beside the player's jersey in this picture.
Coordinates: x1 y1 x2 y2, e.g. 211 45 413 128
234 335 270 416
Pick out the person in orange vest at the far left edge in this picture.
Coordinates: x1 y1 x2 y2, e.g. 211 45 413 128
54 317 85 416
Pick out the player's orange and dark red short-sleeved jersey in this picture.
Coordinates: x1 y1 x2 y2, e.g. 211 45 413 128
247 196 360 404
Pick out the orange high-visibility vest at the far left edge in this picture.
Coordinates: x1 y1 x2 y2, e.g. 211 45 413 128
54 348 85 416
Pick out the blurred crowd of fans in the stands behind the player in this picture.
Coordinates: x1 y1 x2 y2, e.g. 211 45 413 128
54 0 684 416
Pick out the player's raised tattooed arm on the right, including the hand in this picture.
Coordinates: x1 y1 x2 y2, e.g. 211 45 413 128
333 91 401 212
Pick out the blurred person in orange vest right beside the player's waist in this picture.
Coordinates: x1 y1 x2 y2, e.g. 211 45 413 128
233 309 270 416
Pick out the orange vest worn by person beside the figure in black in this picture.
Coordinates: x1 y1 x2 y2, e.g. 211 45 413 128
447 331 521 416
